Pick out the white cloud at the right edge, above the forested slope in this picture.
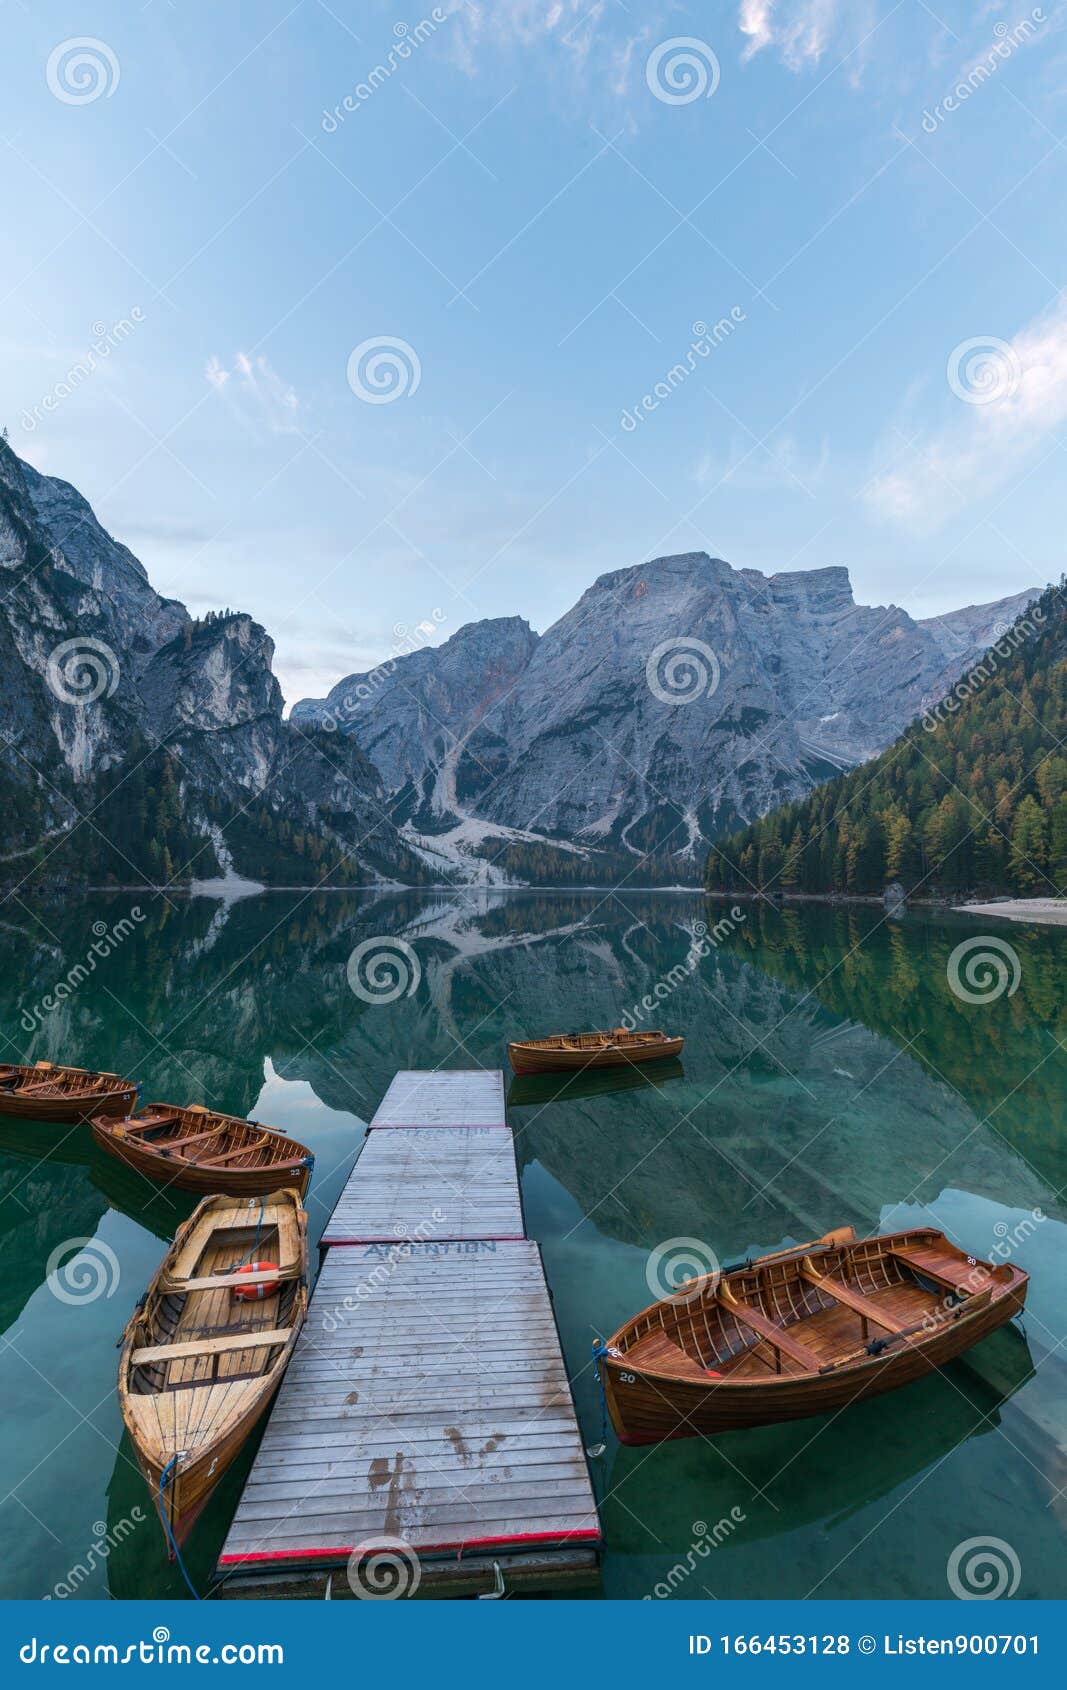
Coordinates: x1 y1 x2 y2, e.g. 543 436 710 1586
864 294 1067 532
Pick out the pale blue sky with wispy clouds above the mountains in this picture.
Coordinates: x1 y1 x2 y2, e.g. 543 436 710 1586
0 0 1067 701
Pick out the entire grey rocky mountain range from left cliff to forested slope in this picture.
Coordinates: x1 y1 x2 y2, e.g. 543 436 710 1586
0 443 1035 884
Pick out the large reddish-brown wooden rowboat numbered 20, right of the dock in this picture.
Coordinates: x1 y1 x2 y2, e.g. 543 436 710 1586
597 1227 1028 1443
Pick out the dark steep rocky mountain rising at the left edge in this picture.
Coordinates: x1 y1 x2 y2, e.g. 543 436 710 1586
0 441 424 884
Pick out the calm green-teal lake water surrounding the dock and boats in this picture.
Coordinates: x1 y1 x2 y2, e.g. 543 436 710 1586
0 891 1067 1599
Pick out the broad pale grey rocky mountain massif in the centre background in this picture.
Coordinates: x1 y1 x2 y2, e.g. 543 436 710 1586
293 553 1037 879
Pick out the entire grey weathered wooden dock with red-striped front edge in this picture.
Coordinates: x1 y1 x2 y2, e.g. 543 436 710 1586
218 1070 600 1597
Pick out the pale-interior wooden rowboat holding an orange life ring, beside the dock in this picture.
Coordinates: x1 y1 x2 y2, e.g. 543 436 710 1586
118 1191 308 1558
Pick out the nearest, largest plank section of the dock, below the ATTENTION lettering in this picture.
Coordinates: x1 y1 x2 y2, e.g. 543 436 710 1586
220 1237 599 1570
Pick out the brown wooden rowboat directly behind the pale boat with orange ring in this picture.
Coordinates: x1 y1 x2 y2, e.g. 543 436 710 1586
93 1104 315 1197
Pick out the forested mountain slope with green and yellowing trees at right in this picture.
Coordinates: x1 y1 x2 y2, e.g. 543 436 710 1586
707 583 1067 899
